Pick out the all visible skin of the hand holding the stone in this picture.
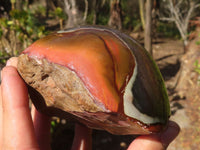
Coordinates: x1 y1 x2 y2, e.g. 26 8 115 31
0 58 180 150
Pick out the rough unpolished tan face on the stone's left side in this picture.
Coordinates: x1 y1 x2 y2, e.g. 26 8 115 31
18 54 105 112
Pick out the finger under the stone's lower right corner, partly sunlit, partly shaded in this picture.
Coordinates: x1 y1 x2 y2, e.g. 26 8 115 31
128 121 180 150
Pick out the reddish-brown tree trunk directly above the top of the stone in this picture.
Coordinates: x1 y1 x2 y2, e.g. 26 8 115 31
108 0 122 30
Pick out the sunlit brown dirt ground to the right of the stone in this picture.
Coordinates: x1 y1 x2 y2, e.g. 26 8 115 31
153 39 200 150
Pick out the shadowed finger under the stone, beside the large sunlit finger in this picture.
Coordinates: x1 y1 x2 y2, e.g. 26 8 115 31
31 105 51 150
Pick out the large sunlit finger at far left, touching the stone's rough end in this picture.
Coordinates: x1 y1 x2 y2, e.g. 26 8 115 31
1 66 38 149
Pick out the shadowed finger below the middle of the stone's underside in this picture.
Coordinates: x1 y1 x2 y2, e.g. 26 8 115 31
71 124 92 150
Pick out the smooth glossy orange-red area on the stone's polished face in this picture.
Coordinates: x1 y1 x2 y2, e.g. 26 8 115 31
24 30 135 112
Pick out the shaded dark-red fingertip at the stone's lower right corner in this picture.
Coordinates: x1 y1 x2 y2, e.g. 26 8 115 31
161 121 180 147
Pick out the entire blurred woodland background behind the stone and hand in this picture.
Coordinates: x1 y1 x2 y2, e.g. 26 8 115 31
0 0 200 150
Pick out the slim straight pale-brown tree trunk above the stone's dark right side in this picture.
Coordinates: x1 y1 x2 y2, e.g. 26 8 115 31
144 0 153 56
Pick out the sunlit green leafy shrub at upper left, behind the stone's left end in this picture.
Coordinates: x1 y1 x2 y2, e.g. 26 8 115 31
0 2 48 62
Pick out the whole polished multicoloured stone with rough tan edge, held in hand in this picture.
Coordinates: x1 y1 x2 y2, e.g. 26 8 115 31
18 27 170 135
